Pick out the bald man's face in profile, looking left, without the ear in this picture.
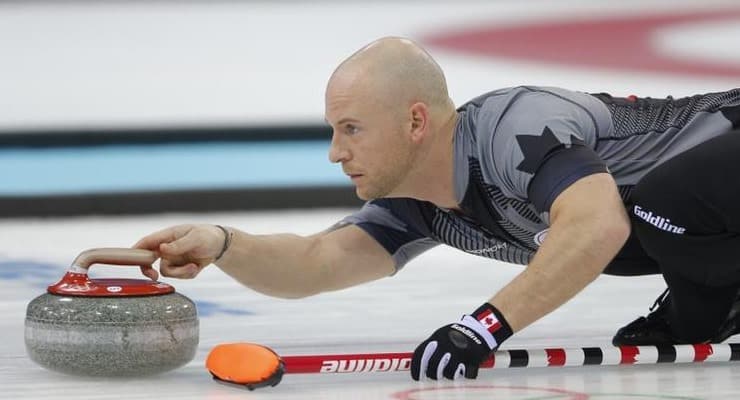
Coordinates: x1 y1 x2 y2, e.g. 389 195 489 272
325 76 414 200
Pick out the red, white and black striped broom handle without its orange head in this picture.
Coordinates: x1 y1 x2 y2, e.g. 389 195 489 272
282 343 740 374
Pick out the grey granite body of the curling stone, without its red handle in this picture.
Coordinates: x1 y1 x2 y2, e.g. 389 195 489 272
25 293 199 377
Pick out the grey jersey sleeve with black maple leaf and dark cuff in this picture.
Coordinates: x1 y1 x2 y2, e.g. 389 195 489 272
479 92 608 213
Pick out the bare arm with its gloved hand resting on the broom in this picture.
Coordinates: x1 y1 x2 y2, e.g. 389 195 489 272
411 173 630 380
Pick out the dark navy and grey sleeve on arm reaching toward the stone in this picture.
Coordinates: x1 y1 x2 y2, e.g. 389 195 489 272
340 199 439 272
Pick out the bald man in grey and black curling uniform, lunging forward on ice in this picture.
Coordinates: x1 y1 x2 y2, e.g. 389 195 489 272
136 38 740 379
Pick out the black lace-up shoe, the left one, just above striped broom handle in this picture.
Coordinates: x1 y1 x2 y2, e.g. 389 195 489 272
612 289 685 346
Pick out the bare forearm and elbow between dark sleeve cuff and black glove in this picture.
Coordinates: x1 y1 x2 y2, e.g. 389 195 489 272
490 173 630 332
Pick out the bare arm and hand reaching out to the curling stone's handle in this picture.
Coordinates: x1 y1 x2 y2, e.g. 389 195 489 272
134 225 394 298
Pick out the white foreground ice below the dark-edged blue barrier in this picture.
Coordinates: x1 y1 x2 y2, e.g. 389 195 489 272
0 210 740 400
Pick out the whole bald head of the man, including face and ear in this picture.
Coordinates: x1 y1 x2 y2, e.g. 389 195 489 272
325 37 457 200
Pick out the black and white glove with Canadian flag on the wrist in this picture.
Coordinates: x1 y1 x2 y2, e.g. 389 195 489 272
411 303 512 381
